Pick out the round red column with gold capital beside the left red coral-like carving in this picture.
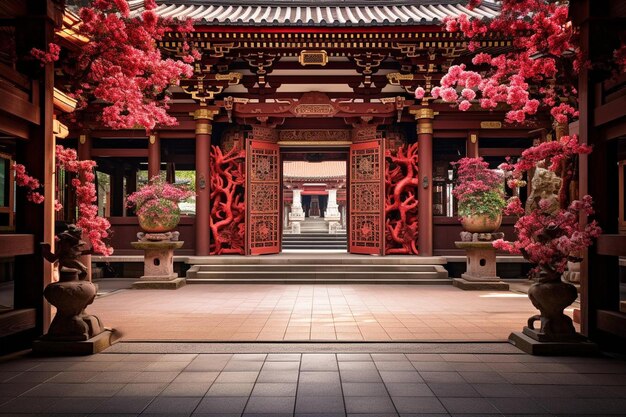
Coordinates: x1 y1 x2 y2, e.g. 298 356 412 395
193 109 218 256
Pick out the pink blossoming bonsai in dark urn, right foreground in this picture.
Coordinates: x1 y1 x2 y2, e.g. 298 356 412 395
493 136 602 341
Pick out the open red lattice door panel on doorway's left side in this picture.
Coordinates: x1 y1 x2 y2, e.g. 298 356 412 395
246 139 281 255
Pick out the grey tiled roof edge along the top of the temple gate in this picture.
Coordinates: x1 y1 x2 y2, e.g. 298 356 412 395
128 0 498 26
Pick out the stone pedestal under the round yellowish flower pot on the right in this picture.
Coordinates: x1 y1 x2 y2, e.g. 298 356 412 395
452 233 509 291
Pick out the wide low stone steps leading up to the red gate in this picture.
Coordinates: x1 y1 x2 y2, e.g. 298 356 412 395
187 254 452 285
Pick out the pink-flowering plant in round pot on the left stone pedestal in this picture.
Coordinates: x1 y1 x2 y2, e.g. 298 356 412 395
128 177 194 233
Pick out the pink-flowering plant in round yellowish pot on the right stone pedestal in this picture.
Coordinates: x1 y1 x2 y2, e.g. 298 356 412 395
452 158 506 233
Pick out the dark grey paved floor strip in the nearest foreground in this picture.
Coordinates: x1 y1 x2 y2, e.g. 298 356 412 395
0 347 626 417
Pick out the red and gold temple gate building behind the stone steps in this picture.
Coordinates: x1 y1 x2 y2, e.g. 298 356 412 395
72 0 551 257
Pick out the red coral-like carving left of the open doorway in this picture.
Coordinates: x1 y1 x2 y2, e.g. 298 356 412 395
209 146 246 255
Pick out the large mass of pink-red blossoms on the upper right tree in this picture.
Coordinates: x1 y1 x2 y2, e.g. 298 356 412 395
431 0 577 123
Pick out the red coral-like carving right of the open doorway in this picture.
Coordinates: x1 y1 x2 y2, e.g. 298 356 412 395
385 143 419 255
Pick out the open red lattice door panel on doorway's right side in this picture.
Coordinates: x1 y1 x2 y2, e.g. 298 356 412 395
348 140 385 255
